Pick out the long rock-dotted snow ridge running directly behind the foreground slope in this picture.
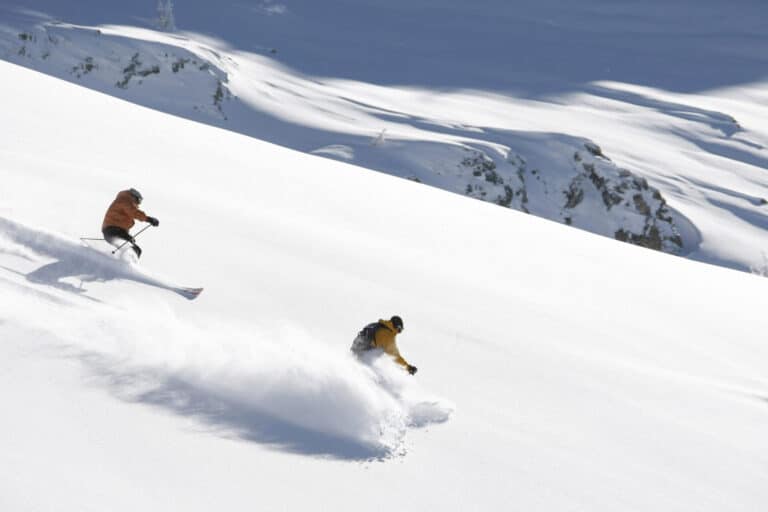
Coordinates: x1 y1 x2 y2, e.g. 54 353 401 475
0 14 699 254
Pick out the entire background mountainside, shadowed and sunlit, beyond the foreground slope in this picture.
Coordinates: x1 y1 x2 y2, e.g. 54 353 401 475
0 0 768 270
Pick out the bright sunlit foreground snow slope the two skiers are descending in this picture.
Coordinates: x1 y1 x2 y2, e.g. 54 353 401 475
0 62 768 511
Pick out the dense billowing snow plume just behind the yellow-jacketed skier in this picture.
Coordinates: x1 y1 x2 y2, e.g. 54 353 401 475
76 316 408 458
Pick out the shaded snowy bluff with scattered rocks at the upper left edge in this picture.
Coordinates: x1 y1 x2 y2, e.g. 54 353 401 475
0 23 233 120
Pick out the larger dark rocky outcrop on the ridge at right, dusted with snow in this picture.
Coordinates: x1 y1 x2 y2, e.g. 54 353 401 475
458 141 684 254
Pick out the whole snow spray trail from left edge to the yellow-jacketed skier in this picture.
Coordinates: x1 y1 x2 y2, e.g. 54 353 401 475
0 218 453 460
